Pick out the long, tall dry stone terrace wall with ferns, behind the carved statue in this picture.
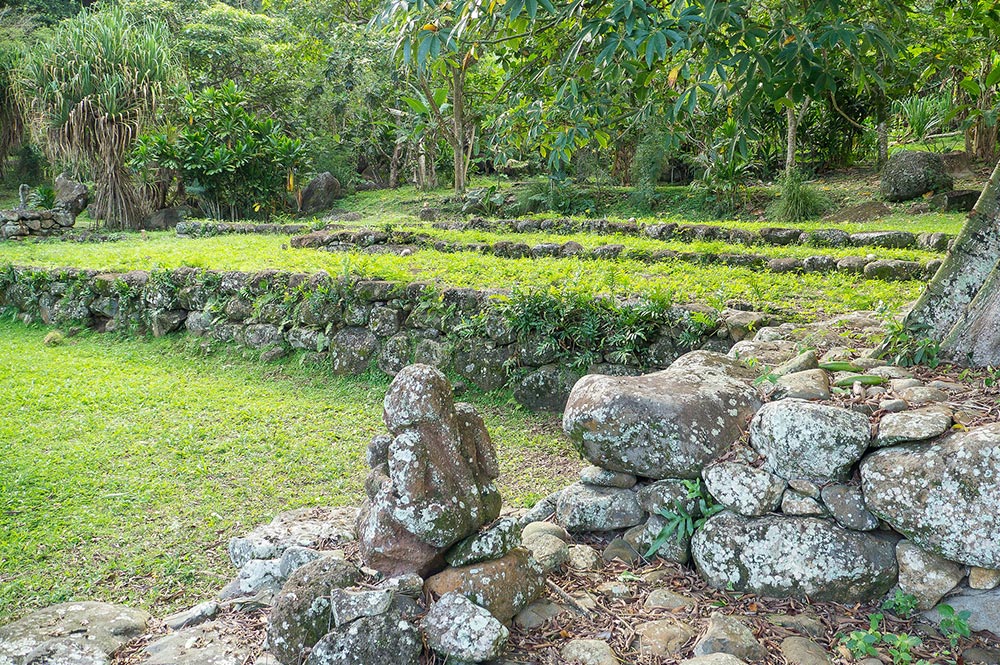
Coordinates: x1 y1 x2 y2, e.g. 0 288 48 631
0 268 769 410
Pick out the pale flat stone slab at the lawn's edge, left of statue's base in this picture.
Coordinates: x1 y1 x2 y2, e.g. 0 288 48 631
228 508 358 568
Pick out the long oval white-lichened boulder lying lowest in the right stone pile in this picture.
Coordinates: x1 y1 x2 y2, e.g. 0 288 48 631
691 511 897 603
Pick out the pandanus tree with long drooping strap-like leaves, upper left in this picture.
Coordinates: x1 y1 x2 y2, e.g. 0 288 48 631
18 7 175 228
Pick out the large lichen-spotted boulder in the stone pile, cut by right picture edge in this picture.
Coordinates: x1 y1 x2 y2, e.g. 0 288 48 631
861 423 1000 568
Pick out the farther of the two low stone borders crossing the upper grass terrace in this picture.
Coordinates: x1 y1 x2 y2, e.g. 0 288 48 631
442 217 954 252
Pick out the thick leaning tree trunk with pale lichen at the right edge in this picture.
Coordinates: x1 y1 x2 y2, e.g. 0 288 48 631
905 159 1000 366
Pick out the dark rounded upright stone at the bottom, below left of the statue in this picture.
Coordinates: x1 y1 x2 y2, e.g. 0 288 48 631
267 557 361 665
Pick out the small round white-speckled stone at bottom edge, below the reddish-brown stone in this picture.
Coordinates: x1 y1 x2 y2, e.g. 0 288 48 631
420 593 510 663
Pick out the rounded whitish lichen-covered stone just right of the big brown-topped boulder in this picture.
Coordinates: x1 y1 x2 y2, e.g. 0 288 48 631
750 399 871 480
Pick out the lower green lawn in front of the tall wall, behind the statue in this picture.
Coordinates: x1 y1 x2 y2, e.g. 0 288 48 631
0 318 580 625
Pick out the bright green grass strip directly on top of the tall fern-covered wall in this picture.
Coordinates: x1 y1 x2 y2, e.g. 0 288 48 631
0 232 922 319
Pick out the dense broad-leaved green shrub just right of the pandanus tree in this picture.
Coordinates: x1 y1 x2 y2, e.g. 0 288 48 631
134 82 306 220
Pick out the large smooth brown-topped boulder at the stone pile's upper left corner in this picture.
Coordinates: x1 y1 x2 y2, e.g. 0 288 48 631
563 351 760 478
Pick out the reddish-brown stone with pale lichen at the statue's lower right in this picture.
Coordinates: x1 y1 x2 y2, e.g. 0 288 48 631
424 548 545 622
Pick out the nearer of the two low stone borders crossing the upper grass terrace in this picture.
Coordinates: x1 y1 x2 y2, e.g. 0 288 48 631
291 229 941 281
